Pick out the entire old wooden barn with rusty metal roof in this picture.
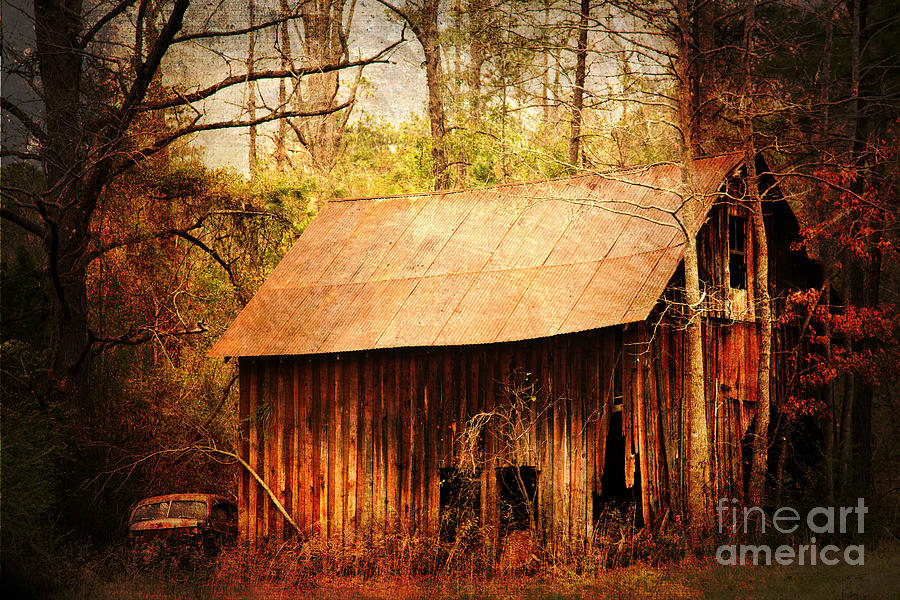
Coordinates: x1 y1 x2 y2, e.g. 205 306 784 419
212 154 810 548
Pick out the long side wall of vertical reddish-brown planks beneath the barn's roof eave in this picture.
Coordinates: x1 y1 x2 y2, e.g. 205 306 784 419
239 328 622 547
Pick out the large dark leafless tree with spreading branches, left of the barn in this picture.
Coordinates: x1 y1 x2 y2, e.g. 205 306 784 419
0 0 393 404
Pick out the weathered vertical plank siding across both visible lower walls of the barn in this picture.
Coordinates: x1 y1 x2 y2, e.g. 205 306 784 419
239 323 758 549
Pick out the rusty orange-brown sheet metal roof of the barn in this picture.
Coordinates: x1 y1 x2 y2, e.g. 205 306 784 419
210 153 742 356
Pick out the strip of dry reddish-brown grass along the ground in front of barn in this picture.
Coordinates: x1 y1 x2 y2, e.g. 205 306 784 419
54 540 900 600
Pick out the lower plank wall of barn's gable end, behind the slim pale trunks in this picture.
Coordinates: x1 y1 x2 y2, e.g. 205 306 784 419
623 319 759 525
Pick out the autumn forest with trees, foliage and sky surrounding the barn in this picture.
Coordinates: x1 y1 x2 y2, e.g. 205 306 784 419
0 0 900 589
